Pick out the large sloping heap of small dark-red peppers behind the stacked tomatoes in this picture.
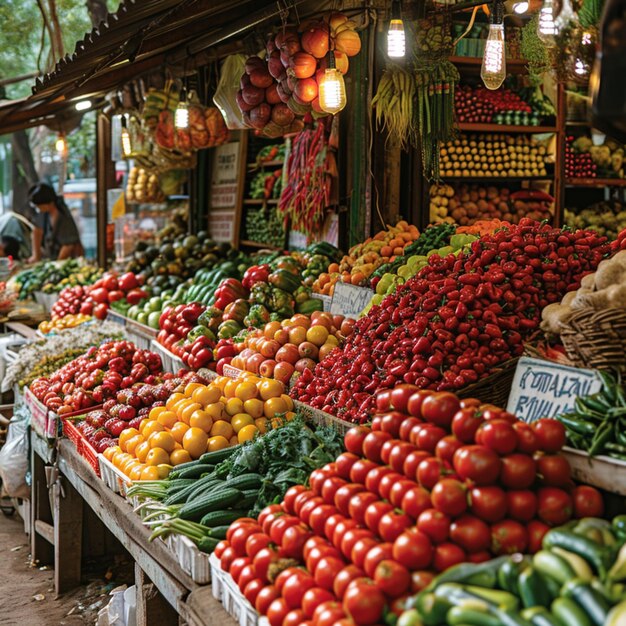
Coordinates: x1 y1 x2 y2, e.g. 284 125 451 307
294 218 610 422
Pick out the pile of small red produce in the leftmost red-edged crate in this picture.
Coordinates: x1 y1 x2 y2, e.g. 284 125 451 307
30 341 163 415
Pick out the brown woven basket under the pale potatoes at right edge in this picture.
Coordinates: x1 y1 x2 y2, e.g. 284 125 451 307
561 307 626 372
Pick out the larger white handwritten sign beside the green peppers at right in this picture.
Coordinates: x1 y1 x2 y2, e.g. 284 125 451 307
507 357 602 423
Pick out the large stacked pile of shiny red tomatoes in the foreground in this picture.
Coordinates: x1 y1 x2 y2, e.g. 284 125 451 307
216 385 602 626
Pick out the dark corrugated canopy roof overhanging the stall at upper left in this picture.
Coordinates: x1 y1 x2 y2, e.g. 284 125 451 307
0 0 312 135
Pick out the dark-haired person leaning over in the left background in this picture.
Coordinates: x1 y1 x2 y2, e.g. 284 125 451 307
28 183 85 261
